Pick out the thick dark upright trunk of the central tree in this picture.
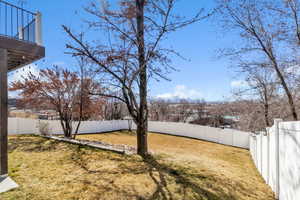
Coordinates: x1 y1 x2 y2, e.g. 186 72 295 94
136 0 148 157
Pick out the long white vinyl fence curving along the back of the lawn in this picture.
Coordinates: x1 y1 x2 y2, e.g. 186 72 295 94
9 118 250 149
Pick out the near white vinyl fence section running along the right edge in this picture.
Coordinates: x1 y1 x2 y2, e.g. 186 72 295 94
250 119 300 200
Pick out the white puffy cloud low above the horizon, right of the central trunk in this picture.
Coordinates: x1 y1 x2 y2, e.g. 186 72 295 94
156 85 203 99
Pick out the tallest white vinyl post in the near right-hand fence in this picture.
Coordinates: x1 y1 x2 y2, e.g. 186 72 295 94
274 119 282 199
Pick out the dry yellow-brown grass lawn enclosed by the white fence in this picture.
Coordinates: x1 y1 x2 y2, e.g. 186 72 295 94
0 132 274 200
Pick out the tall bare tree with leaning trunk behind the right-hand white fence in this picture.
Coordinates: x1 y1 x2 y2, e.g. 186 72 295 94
218 0 298 120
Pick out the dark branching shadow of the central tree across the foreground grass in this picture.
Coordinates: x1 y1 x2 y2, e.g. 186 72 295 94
72 147 236 200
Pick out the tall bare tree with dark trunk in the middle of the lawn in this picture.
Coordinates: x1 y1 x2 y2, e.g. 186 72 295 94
63 0 209 156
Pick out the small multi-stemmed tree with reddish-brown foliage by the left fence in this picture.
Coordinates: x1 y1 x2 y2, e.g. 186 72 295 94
9 66 98 138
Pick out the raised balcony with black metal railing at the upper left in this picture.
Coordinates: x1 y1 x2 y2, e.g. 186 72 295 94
0 0 45 71
